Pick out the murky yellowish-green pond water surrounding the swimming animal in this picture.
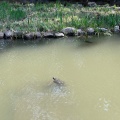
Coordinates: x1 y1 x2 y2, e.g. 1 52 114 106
0 36 120 120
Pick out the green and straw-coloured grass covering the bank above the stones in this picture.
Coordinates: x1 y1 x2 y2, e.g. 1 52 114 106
0 2 120 31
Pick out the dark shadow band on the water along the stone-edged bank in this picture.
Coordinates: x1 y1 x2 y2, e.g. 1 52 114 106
0 35 120 53
